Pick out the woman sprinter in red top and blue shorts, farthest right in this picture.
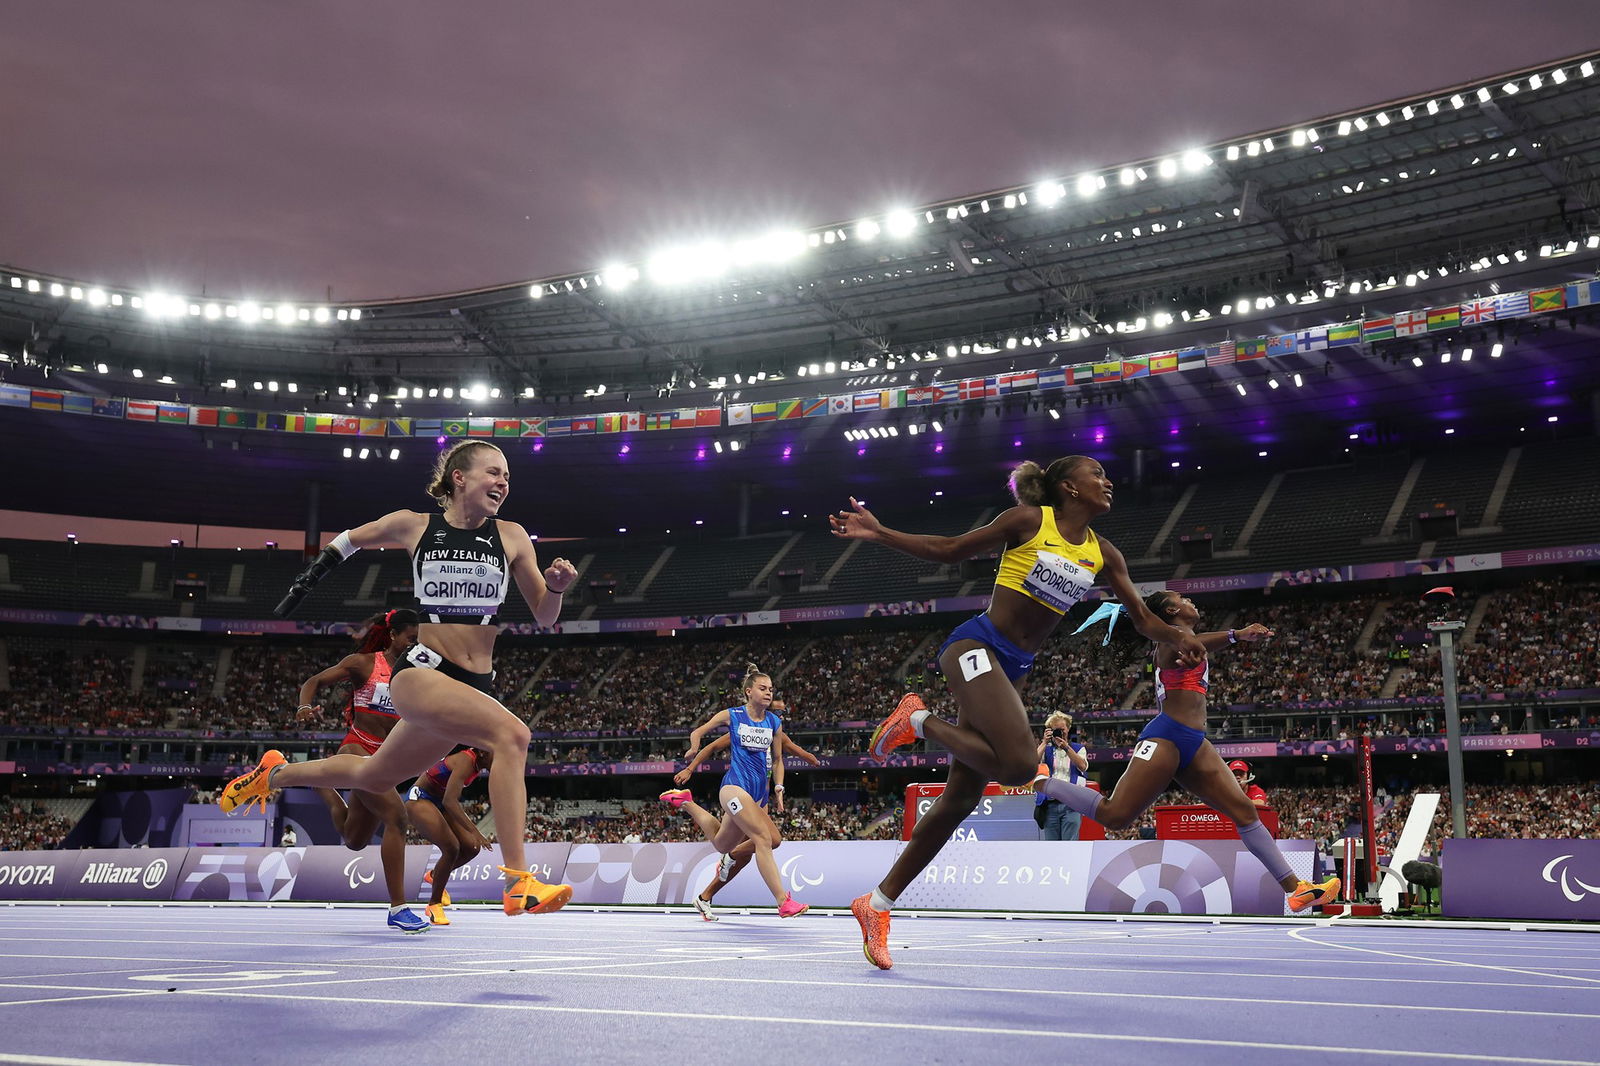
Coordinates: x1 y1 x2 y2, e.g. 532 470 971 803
1034 589 1339 911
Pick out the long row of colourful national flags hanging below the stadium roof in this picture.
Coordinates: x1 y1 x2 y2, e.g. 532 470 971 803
0 282 1600 439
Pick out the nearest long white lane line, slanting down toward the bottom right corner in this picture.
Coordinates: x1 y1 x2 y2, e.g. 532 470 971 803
168 989 1594 1066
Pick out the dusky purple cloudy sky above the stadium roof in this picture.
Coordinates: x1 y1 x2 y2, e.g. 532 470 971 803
0 0 1600 299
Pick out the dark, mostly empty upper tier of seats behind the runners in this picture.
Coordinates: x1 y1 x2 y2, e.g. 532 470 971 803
0 439 1600 623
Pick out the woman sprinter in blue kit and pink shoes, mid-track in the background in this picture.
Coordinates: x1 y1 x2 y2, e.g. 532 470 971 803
661 663 808 917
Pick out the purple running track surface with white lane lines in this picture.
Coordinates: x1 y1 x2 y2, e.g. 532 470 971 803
0 906 1600 1066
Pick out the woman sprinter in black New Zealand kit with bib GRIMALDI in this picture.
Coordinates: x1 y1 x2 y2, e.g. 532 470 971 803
218 440 578 914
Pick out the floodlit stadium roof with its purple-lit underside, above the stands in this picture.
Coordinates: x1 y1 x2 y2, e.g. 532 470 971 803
0 45 1600 533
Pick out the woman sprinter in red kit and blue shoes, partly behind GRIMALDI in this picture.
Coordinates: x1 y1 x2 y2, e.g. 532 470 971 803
294 610 427 933
